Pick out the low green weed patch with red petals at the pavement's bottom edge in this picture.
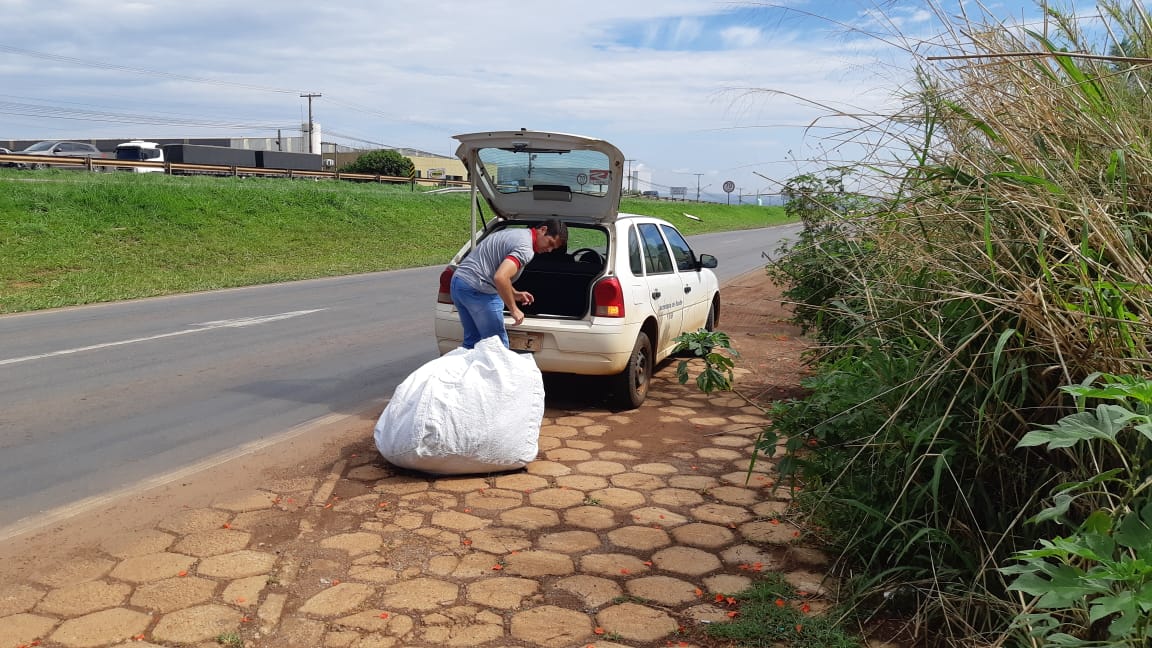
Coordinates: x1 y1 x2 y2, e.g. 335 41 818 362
707 573 863 648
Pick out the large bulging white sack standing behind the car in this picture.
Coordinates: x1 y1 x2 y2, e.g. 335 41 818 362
373 336 544 475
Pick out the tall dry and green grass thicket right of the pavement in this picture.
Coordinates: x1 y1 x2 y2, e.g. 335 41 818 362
764 1 1152 646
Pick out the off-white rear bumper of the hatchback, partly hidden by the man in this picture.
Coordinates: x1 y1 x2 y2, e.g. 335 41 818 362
434 303 641 376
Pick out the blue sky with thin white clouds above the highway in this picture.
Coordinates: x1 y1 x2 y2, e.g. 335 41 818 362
0 0 1059 202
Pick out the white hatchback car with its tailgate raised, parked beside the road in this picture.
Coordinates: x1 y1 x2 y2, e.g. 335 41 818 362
435 130 720 408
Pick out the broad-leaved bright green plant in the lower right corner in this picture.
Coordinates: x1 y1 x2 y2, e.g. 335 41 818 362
1000 375 1152 648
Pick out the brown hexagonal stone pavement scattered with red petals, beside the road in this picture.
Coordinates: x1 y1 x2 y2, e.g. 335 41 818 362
0 282 829 648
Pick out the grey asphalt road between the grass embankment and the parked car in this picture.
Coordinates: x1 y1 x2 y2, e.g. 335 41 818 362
0 221 798 530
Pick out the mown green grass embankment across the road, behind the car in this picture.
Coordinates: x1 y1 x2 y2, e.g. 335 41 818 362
0 169 788 312
